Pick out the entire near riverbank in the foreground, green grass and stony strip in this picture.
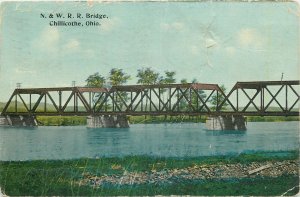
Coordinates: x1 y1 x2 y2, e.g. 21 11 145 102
0 151 299 196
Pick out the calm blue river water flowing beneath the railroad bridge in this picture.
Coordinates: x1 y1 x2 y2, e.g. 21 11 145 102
0 122 299 161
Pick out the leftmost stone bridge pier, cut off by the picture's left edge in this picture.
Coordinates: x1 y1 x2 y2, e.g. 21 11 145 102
0 115 38 127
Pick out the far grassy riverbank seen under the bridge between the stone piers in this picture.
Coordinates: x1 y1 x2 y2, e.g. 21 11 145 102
37 116 300 126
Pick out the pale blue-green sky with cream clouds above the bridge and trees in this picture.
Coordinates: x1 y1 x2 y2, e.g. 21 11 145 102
0 1 300 101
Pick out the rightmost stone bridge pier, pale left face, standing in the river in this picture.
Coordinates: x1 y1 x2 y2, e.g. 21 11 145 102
206 115 247 131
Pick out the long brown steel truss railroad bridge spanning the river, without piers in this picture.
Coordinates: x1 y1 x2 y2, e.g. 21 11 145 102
1 80 300 116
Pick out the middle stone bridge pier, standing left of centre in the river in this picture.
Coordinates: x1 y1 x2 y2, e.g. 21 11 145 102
87 115 129 128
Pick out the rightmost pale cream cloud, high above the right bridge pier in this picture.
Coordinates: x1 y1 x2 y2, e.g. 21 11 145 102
237 28 263 48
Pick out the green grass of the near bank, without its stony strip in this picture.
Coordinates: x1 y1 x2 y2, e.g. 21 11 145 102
0 151 299 196
